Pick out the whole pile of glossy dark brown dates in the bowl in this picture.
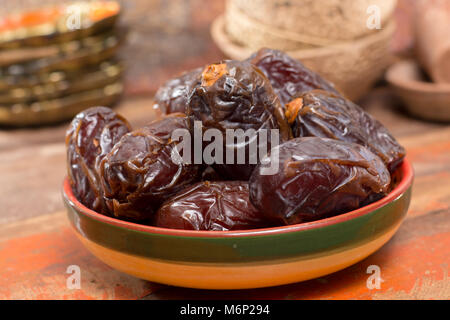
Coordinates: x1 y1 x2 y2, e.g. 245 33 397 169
66 49 405 231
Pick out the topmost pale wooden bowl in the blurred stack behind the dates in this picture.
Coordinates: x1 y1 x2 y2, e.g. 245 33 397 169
229 0 397 44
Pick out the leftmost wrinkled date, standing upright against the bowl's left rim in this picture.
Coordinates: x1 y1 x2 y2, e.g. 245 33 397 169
65 107 131 214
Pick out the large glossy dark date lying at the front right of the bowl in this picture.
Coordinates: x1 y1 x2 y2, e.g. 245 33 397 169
249 137 391 224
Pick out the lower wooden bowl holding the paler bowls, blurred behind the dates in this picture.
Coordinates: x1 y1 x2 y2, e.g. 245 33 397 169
211 16 395 100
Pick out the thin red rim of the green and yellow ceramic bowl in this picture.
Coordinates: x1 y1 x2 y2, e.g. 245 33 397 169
63 159 414 238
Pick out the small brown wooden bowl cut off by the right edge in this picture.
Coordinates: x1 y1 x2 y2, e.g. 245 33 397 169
386 60 450 122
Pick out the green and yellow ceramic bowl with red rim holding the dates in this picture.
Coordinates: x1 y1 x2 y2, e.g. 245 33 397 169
63 160 413 289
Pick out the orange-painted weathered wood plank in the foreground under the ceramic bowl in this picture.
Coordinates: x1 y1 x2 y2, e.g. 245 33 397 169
0 206 450 299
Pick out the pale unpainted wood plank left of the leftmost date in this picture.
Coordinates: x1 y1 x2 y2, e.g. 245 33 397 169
0 143 66 224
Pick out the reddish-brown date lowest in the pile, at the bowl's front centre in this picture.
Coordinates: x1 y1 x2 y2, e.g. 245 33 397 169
155 181 268 231
